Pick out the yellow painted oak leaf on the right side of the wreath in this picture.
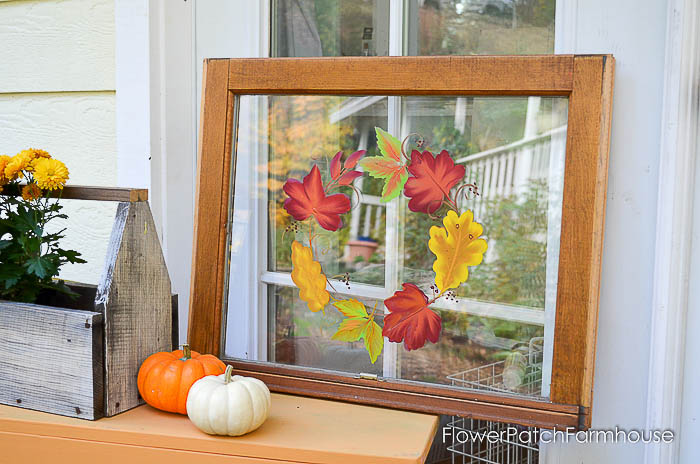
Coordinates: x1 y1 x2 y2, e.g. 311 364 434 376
428 210 487 291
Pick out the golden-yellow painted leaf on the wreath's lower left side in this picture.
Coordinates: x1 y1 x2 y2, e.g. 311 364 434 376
292 240 331 313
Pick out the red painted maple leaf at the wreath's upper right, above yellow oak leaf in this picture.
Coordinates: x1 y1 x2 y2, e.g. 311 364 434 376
404 150 465 214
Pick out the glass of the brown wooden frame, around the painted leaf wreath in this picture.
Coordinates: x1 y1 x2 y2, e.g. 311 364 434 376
225 95 568 397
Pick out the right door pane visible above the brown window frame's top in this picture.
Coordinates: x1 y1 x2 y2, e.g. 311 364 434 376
404 0 556 55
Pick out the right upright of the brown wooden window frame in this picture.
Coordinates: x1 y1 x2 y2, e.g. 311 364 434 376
551 55 614 427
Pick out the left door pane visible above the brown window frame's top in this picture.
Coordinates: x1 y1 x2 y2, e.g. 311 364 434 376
272 0 389 57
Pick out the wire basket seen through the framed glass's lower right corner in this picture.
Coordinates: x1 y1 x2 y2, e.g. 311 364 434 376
447 337 544 398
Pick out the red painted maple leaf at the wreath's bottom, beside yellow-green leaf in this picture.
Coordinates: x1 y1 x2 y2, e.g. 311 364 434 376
382 283 442 351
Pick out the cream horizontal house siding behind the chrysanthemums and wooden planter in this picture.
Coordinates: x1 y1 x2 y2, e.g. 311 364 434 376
0 0 117 283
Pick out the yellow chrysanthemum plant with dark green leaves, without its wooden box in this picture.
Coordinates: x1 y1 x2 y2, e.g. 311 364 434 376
0 148 85 303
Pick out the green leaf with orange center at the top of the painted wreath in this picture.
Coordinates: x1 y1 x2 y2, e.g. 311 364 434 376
360 127 408 202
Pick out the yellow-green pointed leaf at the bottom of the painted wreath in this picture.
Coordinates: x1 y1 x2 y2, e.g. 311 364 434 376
331 298 384 364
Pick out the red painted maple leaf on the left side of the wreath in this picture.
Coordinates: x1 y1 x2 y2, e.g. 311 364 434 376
282 164 350 231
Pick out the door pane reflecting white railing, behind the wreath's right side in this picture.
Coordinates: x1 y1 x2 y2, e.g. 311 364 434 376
400 97 567 309
